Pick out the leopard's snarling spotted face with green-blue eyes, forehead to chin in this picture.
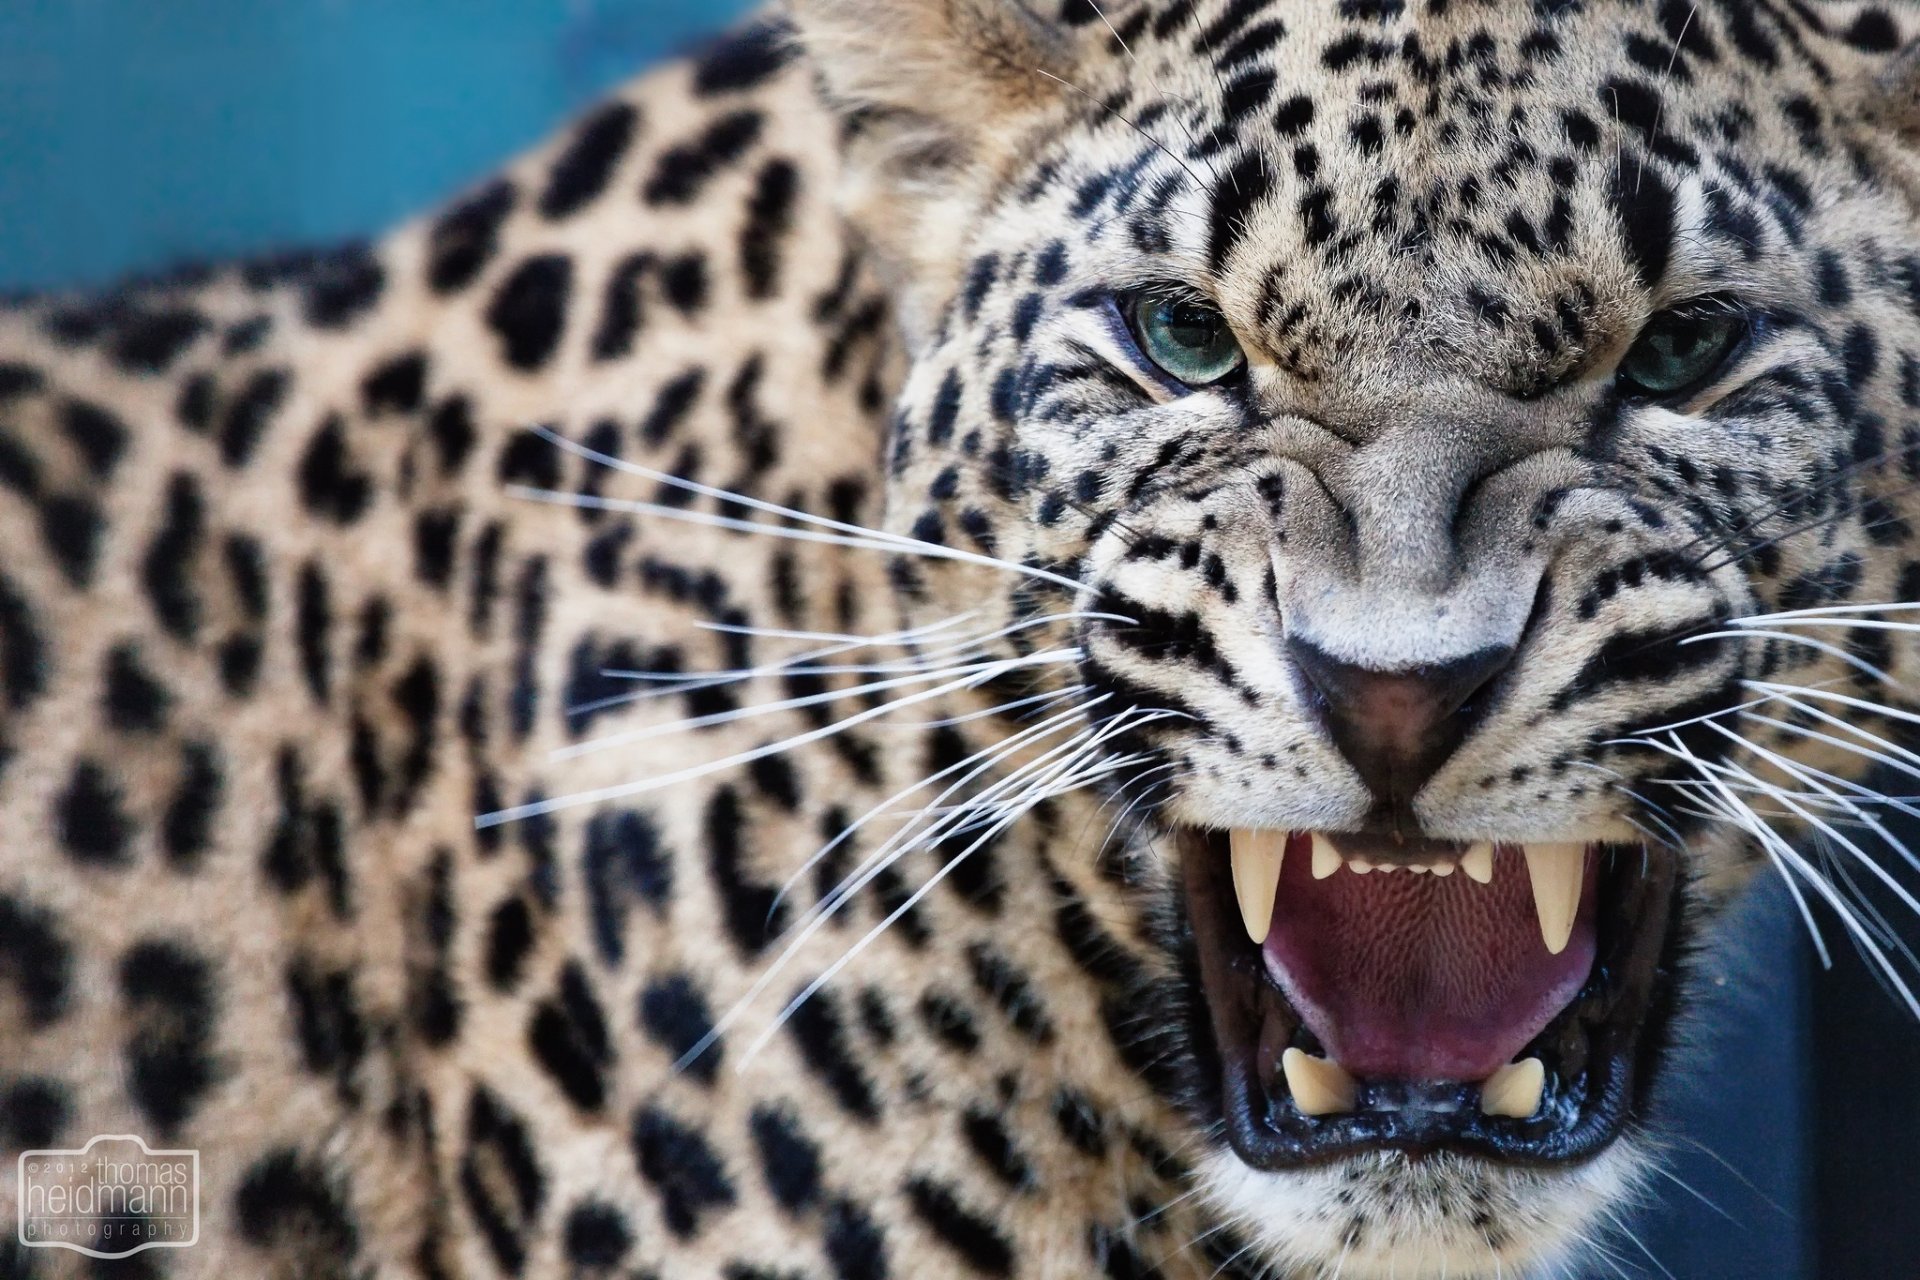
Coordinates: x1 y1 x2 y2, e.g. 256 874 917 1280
802 0 1920 1276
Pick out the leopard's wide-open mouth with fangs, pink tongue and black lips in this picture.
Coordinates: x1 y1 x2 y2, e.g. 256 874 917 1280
1181 831 1678 1171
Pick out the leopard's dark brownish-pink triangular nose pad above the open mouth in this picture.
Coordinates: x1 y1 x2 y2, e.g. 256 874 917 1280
1286 637 1513 816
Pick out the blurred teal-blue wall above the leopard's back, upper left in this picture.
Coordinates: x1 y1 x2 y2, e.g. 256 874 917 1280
0 0 747 290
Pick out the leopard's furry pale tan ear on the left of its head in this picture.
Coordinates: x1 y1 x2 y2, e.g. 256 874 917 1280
791 0 1073 345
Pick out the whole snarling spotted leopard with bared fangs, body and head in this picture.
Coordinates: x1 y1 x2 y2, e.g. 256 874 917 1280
0 0 1920 1280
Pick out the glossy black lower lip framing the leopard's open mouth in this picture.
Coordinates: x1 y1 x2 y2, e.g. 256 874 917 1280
1179 831 1680 1171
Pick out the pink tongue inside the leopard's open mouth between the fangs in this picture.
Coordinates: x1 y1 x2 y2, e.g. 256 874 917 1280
1265 835 1597 1080
